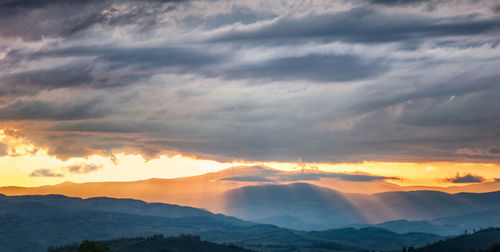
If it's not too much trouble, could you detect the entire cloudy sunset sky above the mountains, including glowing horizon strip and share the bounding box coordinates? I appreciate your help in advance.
[0,0,500,186]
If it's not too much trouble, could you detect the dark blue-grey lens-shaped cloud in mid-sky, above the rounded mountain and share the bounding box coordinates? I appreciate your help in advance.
[224,55,386,82]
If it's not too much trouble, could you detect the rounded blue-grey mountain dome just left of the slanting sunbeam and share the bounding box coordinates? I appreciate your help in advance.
[223,183,368,230]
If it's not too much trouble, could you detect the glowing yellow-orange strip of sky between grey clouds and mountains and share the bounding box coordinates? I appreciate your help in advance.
[0,130,500,187]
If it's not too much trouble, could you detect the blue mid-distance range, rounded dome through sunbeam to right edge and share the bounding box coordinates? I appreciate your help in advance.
[223,183,500,235]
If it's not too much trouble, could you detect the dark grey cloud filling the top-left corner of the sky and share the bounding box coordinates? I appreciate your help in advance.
[0,0,183,41]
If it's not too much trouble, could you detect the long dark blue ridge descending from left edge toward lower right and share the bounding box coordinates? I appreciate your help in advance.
[0,195,442,252]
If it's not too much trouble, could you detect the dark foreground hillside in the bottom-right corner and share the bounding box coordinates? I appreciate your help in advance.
[415,228,500,252]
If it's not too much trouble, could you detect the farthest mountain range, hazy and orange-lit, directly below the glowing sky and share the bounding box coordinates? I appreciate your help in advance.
[0,166,500,213]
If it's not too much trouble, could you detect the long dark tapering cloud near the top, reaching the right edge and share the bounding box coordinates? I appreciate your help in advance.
[213,8,500,43]
